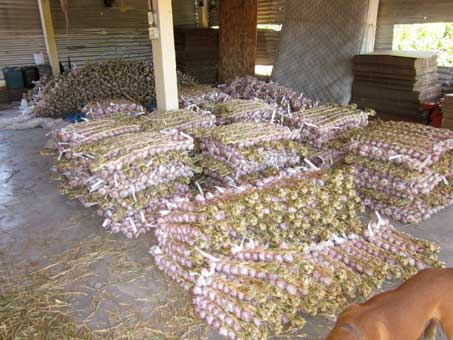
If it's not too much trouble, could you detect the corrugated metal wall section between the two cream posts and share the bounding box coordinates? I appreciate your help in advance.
[51,0,151,66]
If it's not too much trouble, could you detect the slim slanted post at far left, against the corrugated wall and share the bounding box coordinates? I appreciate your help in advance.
[38,0,60,76]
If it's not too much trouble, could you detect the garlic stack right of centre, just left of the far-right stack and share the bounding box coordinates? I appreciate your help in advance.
[284,104,374,168]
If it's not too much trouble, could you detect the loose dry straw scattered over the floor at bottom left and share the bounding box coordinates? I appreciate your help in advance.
[0,236,207,340]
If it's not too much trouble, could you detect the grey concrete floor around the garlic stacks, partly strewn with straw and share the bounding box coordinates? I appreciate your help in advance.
[0,105,453,340]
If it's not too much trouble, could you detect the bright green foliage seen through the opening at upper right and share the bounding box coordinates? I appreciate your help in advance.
[393,23,453,67]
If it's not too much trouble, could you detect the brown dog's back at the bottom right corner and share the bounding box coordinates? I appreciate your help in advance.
[326,269,453,340]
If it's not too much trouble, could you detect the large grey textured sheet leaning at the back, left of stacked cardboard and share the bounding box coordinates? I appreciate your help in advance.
[272,0,369,104]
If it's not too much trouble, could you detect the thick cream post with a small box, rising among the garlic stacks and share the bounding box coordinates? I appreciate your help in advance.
[151,0,179,112]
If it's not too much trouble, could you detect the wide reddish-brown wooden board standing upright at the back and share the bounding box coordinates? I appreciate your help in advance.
[219,0,258,82]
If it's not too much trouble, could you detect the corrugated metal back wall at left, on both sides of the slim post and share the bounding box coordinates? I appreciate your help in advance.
[0,0,197,79]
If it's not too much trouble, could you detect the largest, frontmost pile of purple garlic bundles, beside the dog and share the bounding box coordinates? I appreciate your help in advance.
[150,170,442,340]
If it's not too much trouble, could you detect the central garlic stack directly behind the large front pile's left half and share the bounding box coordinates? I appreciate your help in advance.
[195,123,306,186]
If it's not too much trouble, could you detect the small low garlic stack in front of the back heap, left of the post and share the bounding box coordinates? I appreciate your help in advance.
[82,99,146,120]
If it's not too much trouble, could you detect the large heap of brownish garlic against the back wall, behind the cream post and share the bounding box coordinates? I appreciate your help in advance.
[26,59,195,117]
